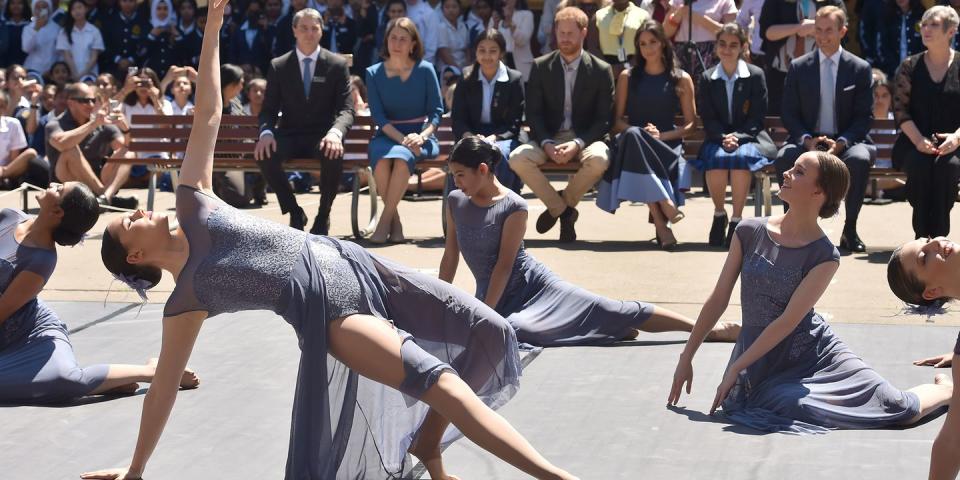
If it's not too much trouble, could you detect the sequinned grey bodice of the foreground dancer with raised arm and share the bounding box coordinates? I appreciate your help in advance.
[164,185,365,321]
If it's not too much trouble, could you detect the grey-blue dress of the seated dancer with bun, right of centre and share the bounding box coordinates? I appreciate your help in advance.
[723,218,920,434]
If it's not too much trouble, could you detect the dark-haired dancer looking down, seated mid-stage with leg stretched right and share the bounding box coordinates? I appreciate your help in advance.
[440,136,740,347]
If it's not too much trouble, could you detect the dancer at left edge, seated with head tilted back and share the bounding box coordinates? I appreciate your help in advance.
[0,182,199,404]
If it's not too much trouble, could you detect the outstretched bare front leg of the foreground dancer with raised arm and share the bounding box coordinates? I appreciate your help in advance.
[328,315,575,479]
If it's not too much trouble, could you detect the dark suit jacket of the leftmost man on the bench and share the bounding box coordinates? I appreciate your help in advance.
[259,47,354,138]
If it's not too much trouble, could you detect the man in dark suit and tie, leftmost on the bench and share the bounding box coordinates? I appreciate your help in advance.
[254,8,354,235]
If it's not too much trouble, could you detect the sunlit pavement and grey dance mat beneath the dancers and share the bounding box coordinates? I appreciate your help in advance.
[0,182,960,480]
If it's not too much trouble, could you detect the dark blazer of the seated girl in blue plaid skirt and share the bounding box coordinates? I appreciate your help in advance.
[697,63,777,158]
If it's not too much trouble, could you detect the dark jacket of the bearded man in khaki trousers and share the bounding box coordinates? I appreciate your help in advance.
[526,50,613,145]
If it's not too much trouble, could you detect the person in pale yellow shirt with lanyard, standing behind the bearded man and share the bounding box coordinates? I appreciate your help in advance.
[596,0,650,75]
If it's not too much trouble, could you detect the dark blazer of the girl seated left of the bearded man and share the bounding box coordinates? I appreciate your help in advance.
[450,67,524,140]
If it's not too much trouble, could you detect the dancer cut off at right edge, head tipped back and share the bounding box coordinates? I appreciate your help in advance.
[887,237,960,480]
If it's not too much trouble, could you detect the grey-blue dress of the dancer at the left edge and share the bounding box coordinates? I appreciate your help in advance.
[0,209,109,404]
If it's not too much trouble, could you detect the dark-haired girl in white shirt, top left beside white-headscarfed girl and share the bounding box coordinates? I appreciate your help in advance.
[57,0,105,81]
